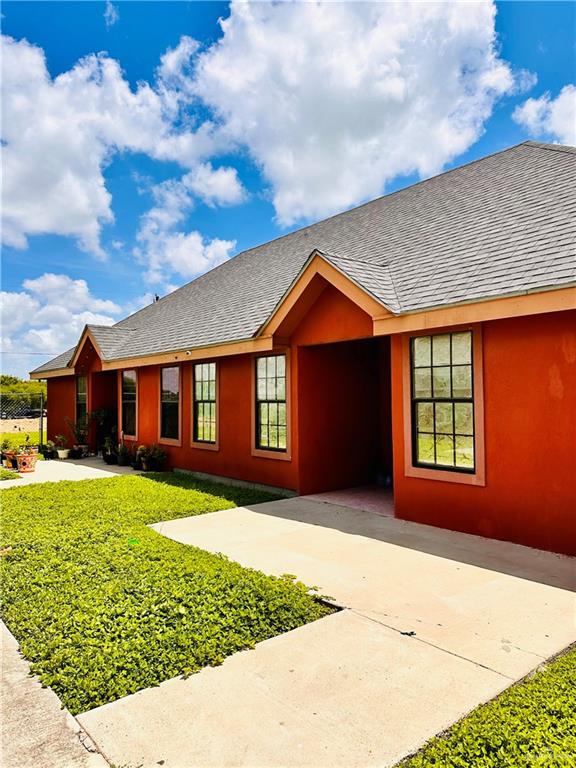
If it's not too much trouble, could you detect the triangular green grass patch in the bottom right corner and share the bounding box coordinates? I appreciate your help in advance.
[400,647,576,768]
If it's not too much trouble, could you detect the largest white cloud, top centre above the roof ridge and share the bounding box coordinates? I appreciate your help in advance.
[188,1,526,224]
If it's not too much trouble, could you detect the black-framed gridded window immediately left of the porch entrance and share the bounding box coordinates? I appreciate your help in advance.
[256,355,287,451]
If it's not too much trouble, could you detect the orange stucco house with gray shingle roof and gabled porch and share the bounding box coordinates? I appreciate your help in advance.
[31,142,576,554]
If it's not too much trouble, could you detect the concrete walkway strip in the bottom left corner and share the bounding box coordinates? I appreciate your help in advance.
[0,622,108,768]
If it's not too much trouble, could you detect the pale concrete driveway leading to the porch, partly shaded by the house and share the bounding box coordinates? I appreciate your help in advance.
[79,498,576,768]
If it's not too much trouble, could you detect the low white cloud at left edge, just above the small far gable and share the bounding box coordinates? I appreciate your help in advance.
[0,273,122,376]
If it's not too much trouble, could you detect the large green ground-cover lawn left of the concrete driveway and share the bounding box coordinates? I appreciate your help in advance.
[0,473,329,714]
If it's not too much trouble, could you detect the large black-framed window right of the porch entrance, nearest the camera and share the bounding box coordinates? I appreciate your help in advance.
[410,331,476,472]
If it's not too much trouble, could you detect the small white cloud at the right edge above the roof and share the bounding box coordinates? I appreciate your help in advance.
[512,85,576,145]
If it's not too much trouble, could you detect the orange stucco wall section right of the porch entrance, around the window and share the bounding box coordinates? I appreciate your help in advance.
[392,311,576,554]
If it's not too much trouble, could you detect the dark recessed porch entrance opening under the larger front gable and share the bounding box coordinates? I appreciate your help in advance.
[298,337,393,513]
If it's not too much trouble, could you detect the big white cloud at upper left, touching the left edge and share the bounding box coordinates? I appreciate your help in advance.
[2,36,222,258]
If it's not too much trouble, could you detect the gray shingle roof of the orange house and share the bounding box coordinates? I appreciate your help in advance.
[31,142,576,372]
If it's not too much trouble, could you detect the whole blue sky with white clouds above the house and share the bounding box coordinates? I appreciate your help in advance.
[2,2,576,375]
